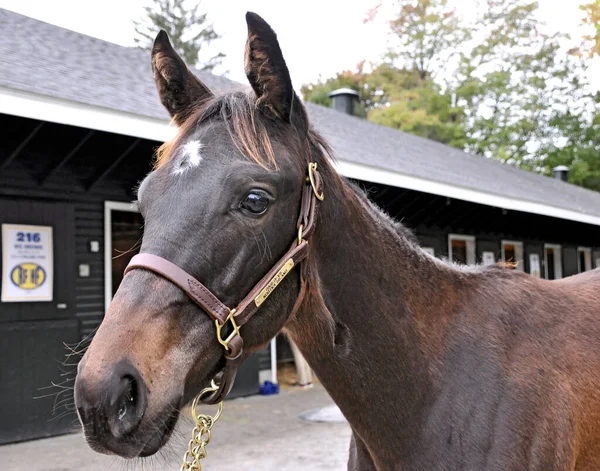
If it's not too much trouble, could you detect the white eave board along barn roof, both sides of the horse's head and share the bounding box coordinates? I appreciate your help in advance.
[0,87,600,226]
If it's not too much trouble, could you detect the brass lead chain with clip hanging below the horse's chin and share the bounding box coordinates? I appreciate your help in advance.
[181,381,223,471]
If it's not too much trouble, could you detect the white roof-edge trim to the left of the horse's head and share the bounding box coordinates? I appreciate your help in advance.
[0,87,176,141]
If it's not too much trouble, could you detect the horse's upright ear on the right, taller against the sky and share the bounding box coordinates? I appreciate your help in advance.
[245,12,307,131]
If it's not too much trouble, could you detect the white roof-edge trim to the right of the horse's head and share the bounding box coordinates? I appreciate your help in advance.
[334,159,600,226]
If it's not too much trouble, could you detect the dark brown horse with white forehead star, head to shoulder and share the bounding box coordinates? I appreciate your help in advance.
[75,13,600,471]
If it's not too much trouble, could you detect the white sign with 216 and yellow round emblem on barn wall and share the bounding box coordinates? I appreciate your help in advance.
[1,224,54,303]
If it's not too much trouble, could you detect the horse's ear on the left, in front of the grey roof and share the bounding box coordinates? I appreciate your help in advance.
[152,30,213,125]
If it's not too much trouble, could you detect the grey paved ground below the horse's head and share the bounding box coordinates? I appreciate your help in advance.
[0,385,350,471]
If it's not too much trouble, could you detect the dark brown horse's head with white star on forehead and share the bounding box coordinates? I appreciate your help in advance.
[75,13,324,457]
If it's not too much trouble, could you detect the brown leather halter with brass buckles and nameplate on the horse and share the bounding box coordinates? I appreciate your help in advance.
[124,163,324,404]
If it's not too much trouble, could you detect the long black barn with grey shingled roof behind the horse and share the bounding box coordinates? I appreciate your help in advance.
[0,9,600,443]
